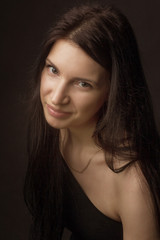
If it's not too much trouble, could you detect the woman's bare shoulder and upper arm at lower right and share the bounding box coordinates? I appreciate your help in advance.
[116,164,160,240]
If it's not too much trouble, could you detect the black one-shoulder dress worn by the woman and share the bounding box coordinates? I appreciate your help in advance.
[63,161,123,240]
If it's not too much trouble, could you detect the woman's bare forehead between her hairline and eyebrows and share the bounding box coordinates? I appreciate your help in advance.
[47,39,107,78]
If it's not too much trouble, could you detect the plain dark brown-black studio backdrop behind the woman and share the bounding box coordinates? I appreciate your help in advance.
[0,0,160,240]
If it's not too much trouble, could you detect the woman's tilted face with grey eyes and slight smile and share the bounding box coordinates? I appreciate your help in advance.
[40,40,109,129]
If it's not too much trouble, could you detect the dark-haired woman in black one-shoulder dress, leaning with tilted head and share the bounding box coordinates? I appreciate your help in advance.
[25,2,160,240]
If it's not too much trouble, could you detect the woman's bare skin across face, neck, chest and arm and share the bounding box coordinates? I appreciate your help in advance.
[40,39,160,240]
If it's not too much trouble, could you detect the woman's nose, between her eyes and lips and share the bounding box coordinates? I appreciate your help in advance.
[51,80,70,105]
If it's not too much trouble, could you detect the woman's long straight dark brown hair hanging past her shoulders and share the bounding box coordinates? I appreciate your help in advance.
[24,3,160,240]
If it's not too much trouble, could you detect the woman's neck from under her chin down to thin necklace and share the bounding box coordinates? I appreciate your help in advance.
[60,125,101,173]
